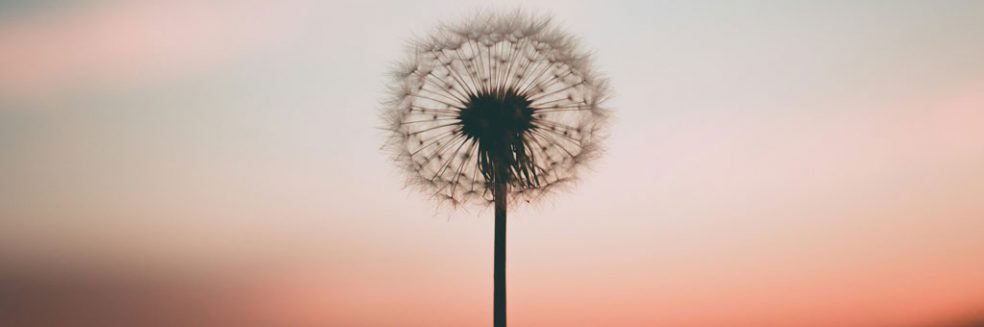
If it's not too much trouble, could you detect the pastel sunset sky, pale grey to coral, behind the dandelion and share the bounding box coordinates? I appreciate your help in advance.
[0,0,984,327]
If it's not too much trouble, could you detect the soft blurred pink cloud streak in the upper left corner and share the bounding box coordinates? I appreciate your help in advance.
[0,1,304,101]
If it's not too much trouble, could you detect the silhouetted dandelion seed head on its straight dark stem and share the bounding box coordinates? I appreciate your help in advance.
[384,12,607,326]
